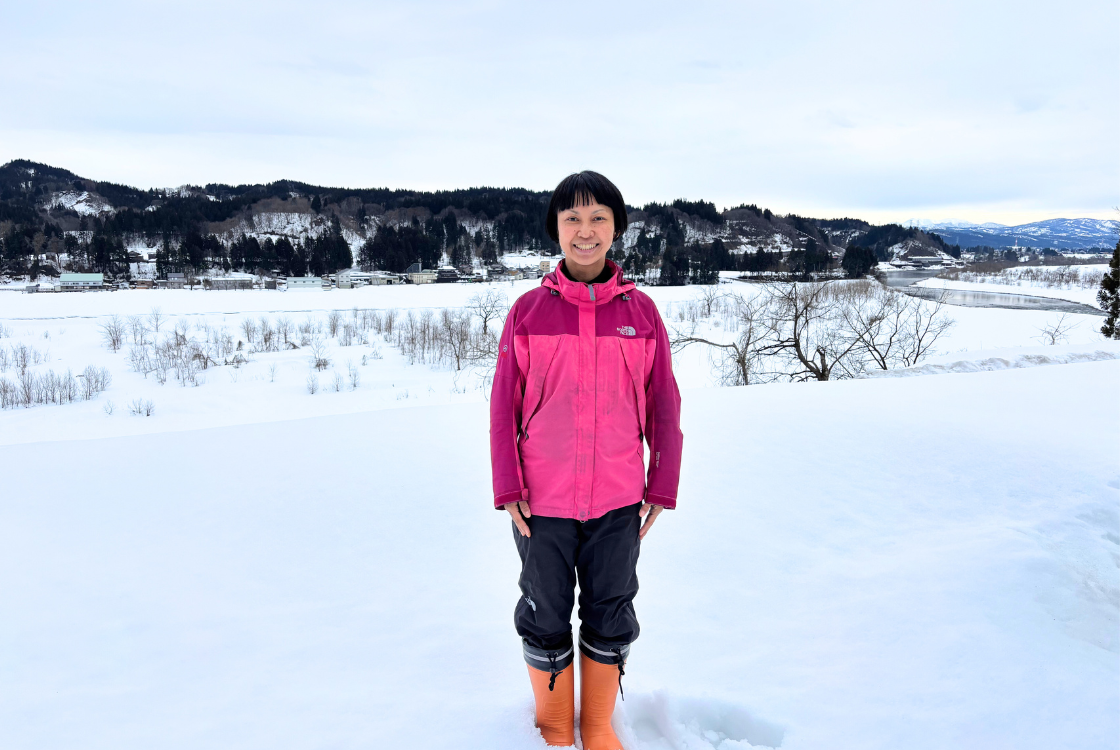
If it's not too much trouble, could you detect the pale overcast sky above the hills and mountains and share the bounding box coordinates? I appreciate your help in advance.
[0,0,1120,224]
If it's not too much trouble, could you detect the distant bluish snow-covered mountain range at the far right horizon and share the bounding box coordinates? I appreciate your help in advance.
[903,218,1120,250]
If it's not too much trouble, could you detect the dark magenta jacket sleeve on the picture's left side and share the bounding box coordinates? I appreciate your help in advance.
[491,302,525,508]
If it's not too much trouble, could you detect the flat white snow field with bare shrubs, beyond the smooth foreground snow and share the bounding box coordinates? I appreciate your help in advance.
[0,280,1120,446]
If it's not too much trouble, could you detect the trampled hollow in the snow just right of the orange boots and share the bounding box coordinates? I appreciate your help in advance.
[614,691,785,750]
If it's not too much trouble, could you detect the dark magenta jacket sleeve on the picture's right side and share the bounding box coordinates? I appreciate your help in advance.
[645,311,684,509]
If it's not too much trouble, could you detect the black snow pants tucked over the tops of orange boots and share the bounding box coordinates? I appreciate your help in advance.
[513,503,642,678]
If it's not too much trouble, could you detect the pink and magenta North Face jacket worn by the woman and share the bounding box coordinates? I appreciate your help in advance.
[491,261,683,521]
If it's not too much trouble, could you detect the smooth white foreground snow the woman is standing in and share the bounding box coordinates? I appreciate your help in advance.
[0,360,1120,750]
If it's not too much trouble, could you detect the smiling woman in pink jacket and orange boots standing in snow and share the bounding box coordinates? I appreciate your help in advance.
[491,171,682,750]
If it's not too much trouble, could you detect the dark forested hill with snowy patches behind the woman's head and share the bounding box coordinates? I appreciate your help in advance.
[0,160,959,283]
